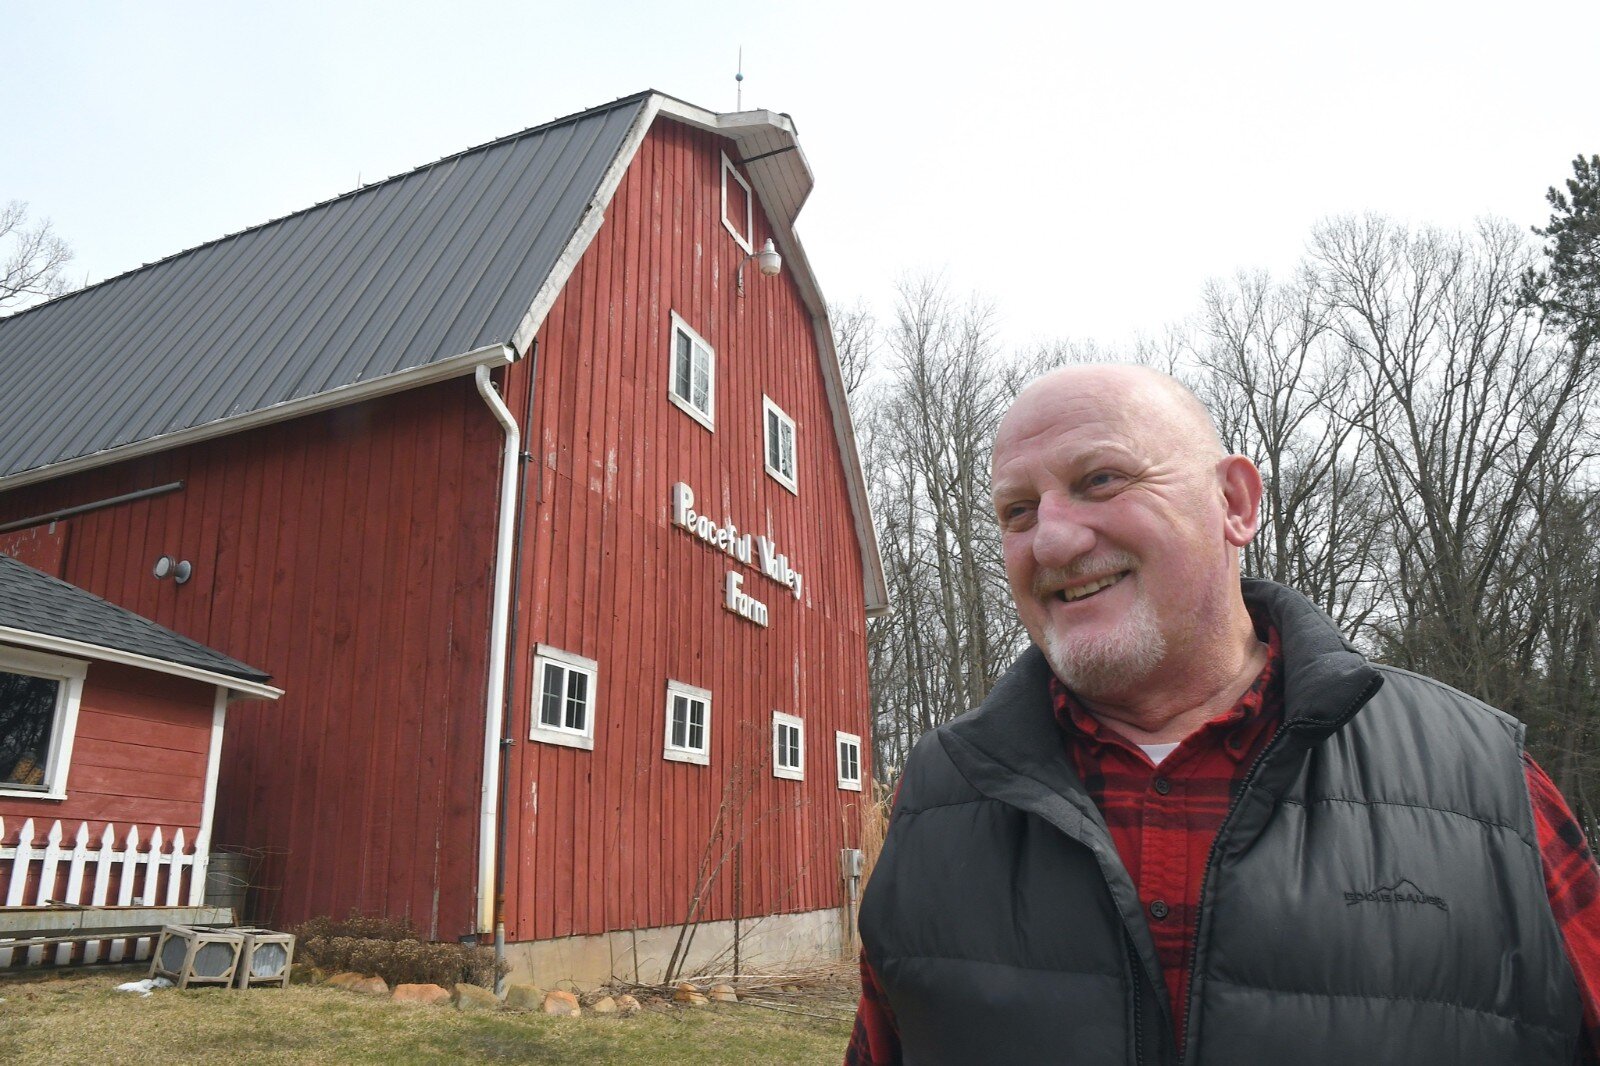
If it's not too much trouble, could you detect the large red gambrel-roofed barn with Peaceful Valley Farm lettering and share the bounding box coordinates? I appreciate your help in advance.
[0,93,886,980]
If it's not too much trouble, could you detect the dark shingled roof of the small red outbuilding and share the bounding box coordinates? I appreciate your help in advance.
[0,555,270,695]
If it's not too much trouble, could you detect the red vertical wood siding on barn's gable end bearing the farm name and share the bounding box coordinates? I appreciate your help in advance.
[506,120,870,940]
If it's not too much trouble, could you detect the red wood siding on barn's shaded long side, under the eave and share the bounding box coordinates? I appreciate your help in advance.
[0,378,501,938]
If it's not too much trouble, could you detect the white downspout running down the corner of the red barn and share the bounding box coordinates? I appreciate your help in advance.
[474,365,522,933]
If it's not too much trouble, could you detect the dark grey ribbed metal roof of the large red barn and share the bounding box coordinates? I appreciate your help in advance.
[0,93,650,479]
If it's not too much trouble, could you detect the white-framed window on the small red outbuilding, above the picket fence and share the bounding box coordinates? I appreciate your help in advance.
[0,648,90,800]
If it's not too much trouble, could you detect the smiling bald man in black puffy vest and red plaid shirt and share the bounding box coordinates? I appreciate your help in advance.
[846,367,1600,1066]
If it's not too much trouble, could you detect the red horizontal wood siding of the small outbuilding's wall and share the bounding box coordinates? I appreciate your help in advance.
[0,663,216,847]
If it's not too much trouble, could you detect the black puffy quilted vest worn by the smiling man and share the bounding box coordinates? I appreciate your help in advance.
[861,581,1581,1066]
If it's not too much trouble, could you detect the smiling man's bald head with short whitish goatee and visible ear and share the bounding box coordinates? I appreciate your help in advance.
[994,367,1259,701]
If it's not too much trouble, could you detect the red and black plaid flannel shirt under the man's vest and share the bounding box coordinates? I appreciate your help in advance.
[845,627,1600,1066]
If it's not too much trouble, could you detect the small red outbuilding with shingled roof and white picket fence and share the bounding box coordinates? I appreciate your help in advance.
[0,555,282,928]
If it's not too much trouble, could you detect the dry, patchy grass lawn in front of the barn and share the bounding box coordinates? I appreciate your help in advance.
[0,967,850,1066]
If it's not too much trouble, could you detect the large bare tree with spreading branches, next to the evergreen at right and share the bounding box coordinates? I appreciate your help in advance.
[1312,218,1595,704]
